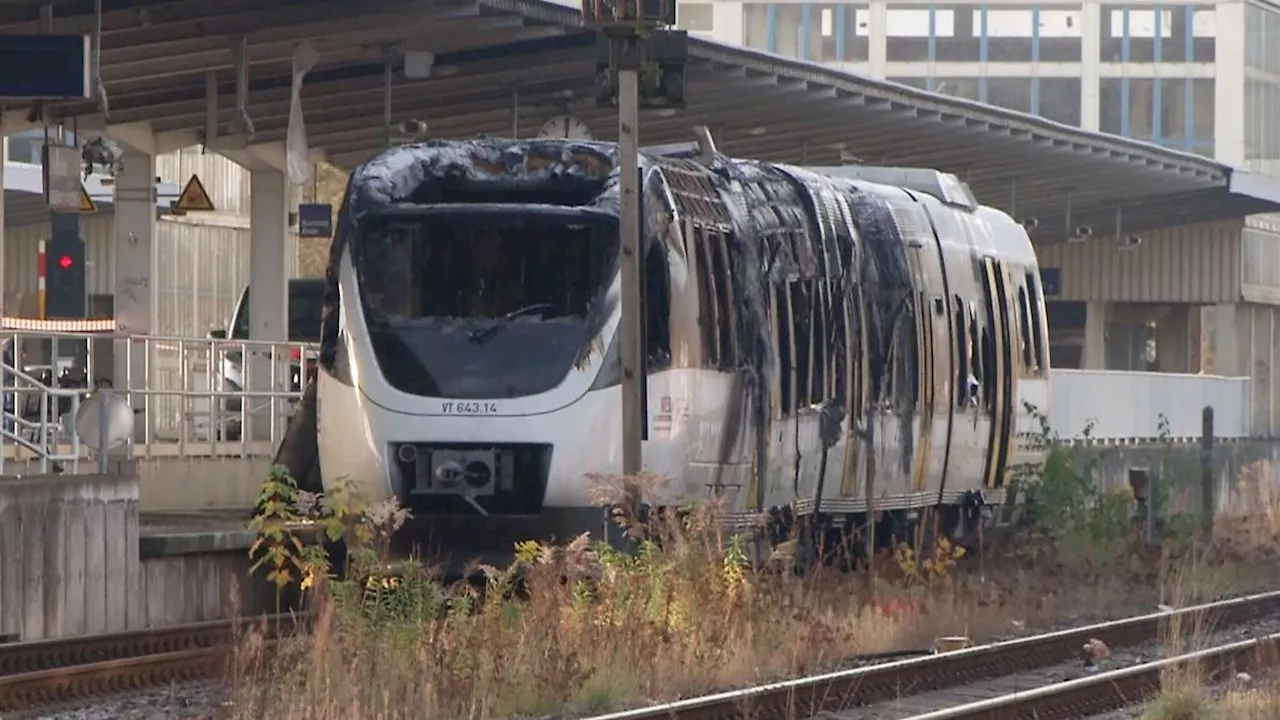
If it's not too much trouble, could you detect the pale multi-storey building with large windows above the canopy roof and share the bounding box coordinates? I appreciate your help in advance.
[680,1,1228,158]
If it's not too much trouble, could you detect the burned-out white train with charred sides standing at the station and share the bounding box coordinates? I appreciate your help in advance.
[290,138,1048,561]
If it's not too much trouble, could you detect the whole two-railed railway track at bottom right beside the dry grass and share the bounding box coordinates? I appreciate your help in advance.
[590,592,1280,720]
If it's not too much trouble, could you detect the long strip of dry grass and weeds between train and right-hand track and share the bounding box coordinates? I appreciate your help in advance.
[233,466,1280,720]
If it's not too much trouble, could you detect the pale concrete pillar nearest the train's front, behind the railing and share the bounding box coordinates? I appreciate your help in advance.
[246,169,285,441]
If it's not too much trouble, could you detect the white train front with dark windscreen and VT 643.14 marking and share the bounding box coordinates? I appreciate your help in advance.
[317,147,620,559]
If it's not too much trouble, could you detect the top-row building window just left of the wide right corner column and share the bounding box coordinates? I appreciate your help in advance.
[1098,5,1217,63]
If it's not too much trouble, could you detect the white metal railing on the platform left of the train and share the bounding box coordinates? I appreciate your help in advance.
[0,332,316,468]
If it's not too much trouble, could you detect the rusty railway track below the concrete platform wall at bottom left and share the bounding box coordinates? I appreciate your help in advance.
[0,614,308,717]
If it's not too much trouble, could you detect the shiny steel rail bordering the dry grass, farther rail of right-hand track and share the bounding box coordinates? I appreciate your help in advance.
[588,592,1280,720]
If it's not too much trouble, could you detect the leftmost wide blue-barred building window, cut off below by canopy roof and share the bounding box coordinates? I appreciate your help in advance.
[742,3,870,63]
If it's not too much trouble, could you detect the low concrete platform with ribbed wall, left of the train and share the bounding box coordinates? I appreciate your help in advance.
[0,474,297,642]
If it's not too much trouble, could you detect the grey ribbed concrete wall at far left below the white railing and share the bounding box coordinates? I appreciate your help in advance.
[0,475,145,641]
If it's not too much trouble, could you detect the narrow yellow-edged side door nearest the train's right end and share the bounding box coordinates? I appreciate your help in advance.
[982,258,1018,488]
